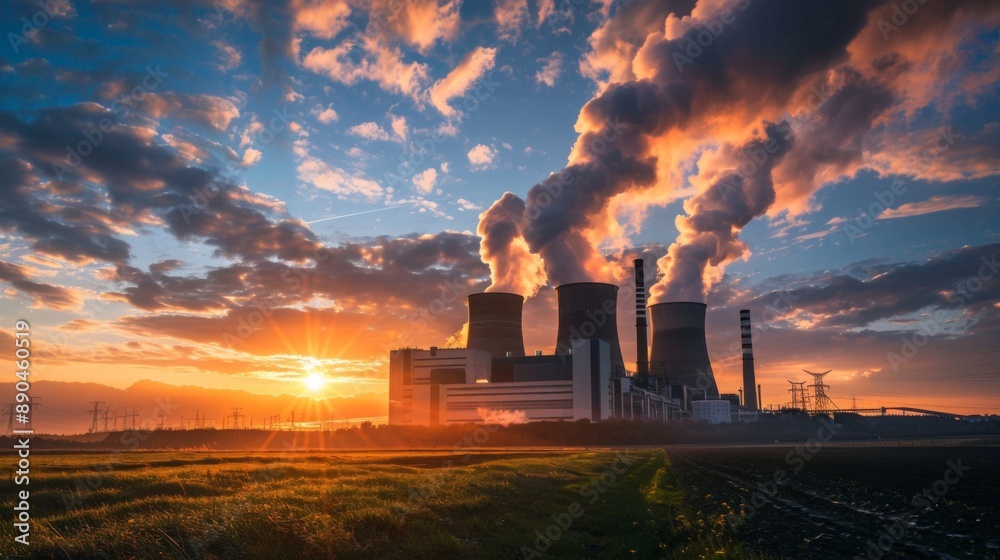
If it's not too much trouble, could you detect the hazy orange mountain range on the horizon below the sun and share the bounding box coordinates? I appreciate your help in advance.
[0,380,389,434]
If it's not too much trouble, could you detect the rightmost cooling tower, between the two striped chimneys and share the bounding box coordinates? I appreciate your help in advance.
[649,302,719,398]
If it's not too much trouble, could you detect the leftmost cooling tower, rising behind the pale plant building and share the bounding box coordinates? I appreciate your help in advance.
[465,292,524,358]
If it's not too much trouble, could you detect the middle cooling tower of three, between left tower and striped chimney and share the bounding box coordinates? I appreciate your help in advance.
[556,282,625,374]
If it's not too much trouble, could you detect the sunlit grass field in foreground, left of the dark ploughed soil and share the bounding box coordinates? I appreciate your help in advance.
[0,450,772,560]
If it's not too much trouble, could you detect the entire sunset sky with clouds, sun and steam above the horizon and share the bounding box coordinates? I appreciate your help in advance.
[0,0,1000,428]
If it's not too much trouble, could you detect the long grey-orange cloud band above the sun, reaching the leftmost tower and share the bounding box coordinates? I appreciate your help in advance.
[104,229,486,320]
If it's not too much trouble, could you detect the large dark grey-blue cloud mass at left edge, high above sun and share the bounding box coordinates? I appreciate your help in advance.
[0,103,316,270]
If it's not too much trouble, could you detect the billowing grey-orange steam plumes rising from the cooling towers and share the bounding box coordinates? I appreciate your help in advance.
[479,0,1000,302]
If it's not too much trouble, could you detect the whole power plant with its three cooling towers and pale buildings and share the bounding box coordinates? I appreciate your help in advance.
[389,259,756,426]
